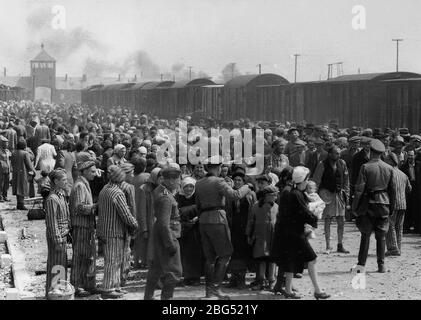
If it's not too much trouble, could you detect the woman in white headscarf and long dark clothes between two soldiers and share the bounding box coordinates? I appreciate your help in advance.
[175,177,204,286]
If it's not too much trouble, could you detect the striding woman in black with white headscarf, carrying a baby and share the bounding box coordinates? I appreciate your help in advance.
[274,166,330,299]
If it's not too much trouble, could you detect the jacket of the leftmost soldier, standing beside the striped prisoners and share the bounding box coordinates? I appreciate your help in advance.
[153,185,181,248]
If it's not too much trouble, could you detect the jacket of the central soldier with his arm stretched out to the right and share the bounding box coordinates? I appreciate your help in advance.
[195,175,249,224]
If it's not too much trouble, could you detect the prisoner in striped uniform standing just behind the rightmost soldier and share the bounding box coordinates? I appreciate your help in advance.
[385,153,412,256]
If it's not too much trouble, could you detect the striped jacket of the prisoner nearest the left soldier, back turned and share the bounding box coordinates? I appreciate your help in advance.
[97,183,138,239]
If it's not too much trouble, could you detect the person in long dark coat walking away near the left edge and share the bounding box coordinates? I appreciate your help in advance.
[11,140,35,210]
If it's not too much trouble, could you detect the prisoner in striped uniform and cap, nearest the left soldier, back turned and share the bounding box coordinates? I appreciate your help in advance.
[97,165,138,298]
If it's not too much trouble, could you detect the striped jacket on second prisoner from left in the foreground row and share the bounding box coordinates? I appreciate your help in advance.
[69,176,95,228]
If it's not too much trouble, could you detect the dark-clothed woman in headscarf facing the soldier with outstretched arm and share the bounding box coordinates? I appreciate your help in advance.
[226,171,256,289]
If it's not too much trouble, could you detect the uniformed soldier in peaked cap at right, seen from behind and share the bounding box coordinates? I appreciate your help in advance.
[352,139,396,273]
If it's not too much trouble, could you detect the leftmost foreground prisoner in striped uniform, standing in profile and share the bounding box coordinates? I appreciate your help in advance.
[45,169,70,299]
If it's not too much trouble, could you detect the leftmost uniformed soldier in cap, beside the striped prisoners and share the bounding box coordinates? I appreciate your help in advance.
[144,167,182,300]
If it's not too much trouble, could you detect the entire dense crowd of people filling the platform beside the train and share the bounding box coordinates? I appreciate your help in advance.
[0,101,421,299]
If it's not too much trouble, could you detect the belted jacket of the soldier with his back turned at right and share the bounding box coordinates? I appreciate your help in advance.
[352,159,396,216]
